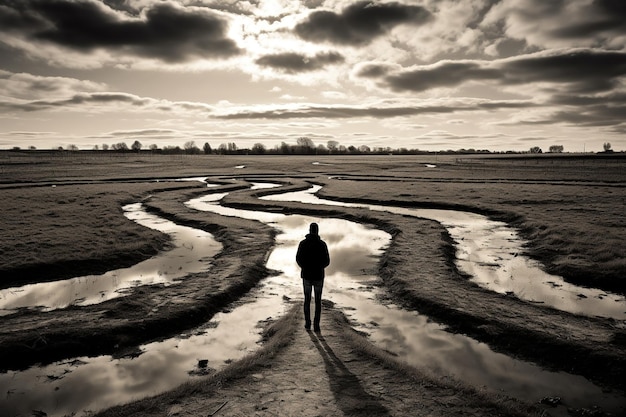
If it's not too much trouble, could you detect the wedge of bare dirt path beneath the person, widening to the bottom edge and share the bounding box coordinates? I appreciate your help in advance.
[157,308,536,417]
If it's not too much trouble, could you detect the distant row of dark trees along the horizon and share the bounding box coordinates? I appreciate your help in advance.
[7,136,613,155]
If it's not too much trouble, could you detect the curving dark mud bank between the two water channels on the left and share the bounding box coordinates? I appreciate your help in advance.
[0,188,273,370]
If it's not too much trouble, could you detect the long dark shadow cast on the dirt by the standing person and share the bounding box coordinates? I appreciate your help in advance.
[309,332,390,416]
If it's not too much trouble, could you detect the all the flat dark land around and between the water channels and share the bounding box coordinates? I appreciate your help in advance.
[0,152,626,415]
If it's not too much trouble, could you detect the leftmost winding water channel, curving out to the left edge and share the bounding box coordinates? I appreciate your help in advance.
[0,204,222,315]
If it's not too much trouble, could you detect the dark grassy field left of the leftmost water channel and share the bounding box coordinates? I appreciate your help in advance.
[0,182,200,288]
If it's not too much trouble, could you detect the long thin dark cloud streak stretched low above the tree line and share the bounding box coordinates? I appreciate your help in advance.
[216,101,535,120]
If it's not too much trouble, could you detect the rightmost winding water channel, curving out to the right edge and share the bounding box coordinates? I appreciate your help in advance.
[261,186,626,320]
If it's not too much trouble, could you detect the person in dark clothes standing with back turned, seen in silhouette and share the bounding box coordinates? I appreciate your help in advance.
[296,223,330,332]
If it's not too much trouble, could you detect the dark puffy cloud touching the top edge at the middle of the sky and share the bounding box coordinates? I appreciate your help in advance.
[295,1,432,46]
